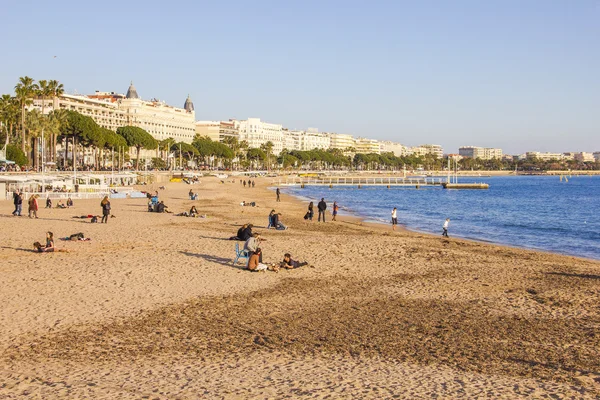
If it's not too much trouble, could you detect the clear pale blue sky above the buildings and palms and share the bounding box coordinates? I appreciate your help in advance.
[0,0,600,153]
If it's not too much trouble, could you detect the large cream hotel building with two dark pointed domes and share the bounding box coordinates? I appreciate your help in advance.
[119,82,196,143]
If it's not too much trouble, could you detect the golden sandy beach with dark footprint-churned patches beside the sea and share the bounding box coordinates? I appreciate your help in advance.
[0,177,600,399]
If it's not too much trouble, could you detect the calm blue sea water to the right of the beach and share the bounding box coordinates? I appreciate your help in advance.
[282,176,600,259]
